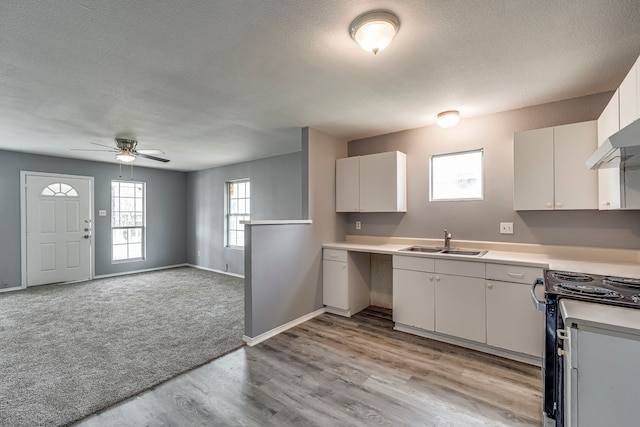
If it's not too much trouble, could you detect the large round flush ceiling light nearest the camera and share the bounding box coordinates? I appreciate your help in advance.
[349,10,400,54]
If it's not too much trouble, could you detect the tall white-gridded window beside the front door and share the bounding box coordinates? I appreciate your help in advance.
[111,181,146,261]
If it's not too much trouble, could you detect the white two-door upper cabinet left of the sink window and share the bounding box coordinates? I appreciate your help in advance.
[336,151,407,212]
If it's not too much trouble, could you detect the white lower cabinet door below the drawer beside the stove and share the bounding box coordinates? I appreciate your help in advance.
[486,281,545,357]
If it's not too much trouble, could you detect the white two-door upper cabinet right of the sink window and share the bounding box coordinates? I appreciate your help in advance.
[513,121,598,210]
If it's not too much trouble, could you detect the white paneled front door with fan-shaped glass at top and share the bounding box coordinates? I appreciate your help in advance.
[23,173,93,286]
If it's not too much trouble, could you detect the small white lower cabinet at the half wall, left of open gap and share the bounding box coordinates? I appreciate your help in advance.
[322,249,370,316]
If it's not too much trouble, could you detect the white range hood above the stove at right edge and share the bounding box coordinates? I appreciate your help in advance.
[587,120,640,169]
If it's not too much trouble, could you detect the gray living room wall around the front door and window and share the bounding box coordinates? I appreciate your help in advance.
[0,151,187,286]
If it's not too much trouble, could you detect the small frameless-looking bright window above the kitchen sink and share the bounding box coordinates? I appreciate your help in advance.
[429,148,484,202]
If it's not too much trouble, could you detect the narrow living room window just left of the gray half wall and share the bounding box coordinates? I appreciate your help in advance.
[227,179,251,248]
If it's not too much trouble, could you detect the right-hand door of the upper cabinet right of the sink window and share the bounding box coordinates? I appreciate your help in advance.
[553,120,598,209]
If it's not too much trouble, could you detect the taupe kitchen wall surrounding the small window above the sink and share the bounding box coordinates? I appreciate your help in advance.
[348,93,640,249]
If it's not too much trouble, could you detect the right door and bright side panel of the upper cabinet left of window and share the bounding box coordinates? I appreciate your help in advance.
[360,151,406,212]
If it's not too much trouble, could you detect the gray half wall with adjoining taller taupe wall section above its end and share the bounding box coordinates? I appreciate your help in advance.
[245,129,347,337]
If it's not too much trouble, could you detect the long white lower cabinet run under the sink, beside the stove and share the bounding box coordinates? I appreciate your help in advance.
[393,255,545,360]
